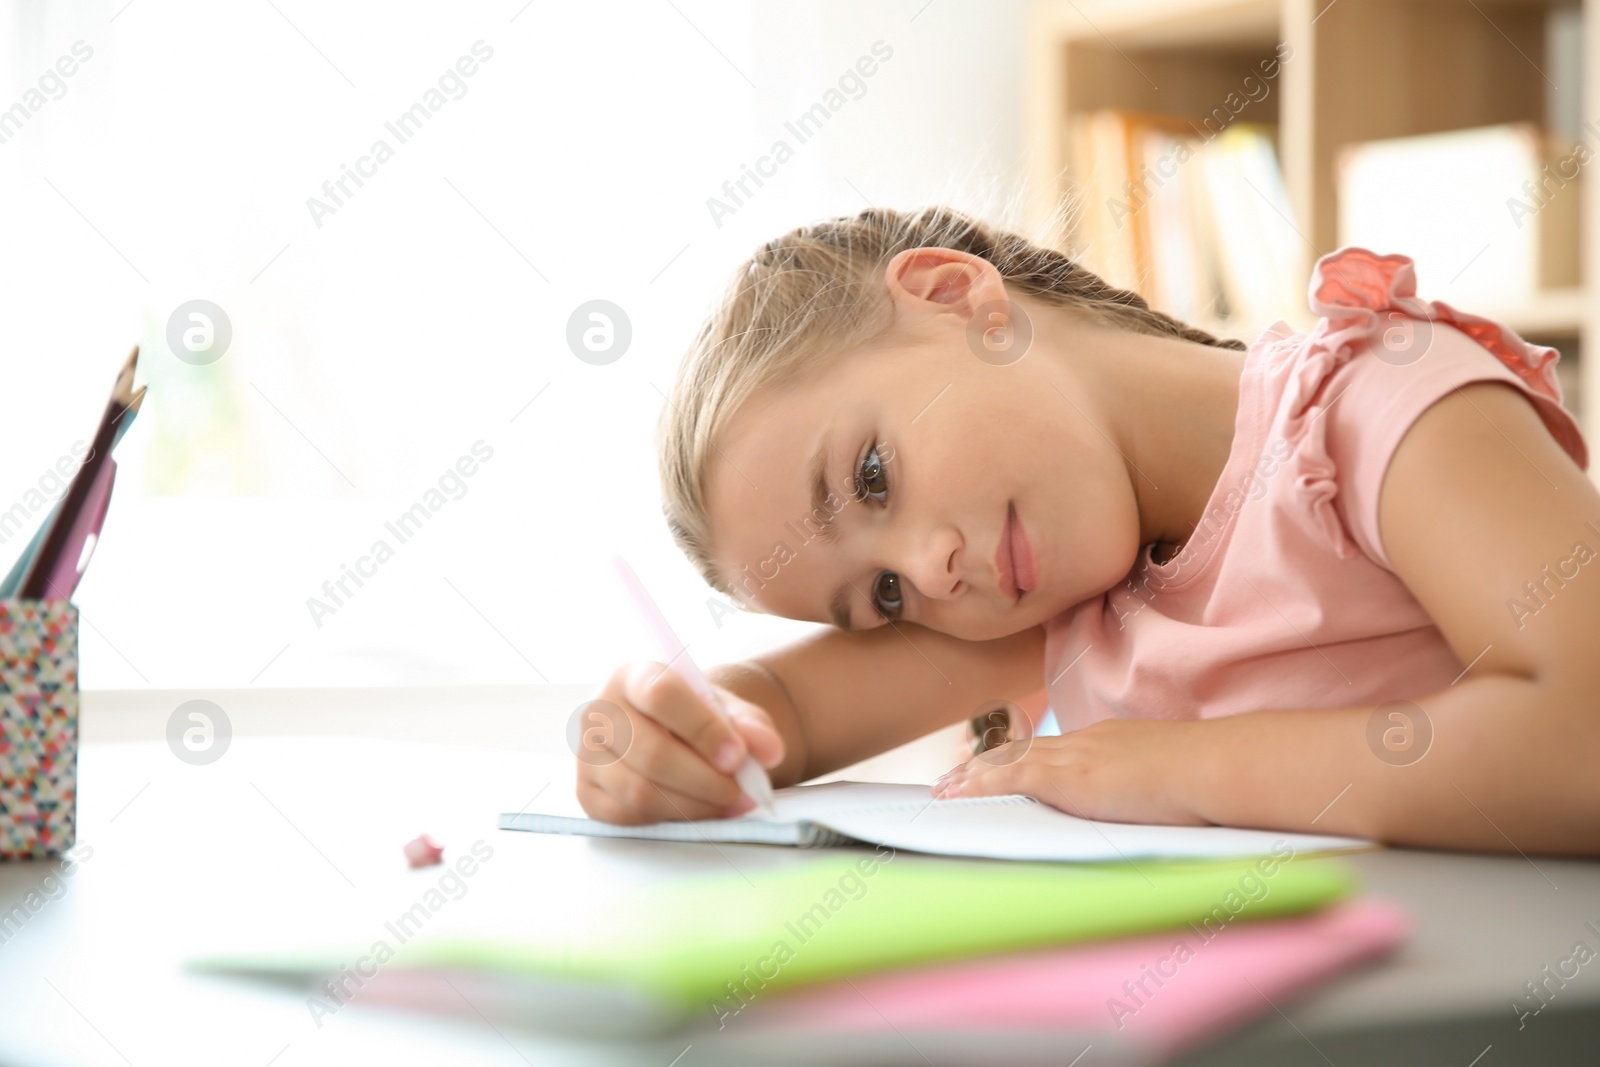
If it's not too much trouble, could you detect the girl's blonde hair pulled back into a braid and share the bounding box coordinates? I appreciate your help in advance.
[656,206,1245,603]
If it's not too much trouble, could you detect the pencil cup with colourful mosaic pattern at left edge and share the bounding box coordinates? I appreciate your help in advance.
[0,600,78,859]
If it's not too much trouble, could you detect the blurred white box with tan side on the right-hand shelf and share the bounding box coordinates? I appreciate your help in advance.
[1338,123,1592,310]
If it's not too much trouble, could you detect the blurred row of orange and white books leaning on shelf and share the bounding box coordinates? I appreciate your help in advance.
[1067,109,1310,339]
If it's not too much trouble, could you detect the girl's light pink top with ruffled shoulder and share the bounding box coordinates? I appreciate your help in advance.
[1045,248,1589,731]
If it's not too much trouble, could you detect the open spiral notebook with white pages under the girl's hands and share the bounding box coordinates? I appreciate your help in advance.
[499,782,1371,862]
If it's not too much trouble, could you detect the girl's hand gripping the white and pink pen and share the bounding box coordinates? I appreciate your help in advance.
[570,661,784,824]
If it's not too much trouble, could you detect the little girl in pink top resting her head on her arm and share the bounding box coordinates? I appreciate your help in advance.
[578,208,1600,853]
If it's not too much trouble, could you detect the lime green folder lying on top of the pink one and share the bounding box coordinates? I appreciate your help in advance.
[197,849,1354,1030]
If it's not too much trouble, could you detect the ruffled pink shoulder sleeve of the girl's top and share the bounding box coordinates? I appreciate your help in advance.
[1280,246,1589,566]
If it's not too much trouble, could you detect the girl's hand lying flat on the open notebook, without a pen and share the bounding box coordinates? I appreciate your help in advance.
[933,718,1208,825]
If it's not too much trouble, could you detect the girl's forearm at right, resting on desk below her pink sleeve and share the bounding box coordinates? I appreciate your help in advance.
[1174,675,1600,854]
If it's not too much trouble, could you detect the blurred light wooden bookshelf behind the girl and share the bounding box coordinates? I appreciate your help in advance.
[1024,0,1600,454]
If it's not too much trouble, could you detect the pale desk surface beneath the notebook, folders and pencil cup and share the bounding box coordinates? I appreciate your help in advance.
[0,686,1600,1067]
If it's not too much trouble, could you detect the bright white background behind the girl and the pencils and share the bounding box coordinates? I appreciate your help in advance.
[0,0,1022,688]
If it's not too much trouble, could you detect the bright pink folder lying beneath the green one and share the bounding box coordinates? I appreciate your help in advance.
[742,899,1408,1059]
